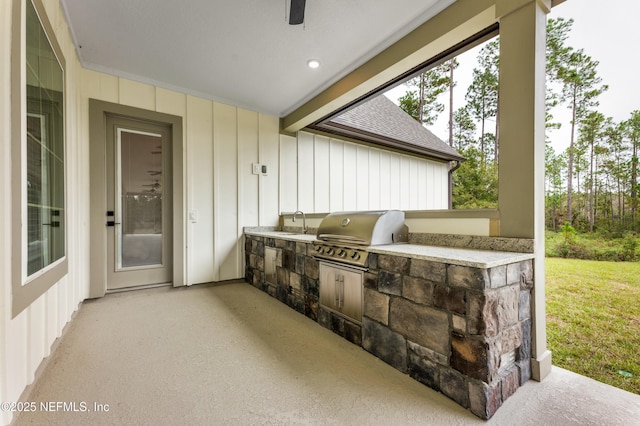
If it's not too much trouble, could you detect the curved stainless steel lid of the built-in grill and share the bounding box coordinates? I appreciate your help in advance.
[317,210,409,246]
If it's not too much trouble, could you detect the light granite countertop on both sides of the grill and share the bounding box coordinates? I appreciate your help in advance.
[245,227,535,269]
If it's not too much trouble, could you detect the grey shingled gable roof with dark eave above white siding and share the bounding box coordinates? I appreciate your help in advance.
[316,95,464,161]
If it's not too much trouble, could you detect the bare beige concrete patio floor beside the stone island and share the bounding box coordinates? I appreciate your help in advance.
[14,282,640,425]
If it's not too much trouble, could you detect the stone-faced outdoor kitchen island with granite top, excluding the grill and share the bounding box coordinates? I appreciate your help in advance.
[245,228,534,419]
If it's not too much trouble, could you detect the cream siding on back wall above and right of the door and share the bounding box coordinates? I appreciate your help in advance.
[83,74,279,284]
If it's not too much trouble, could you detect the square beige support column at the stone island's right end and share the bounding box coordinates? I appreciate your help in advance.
[496,0,551,380]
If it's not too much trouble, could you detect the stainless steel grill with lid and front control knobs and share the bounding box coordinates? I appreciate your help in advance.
[313,210,409,269]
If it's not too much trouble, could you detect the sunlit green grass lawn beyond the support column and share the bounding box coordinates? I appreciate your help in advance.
[545,258,640,395]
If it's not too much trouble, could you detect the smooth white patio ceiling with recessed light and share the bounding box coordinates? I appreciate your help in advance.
[61,0,455,117]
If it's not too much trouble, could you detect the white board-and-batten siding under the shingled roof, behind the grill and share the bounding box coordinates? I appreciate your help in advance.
[280,132,449,213]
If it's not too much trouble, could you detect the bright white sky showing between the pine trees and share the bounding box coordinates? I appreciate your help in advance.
[387,0,640,153]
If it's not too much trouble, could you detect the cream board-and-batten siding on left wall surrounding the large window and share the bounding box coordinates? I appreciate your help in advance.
[0,1,89,424]
